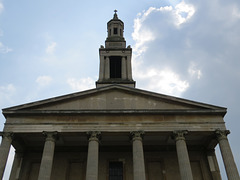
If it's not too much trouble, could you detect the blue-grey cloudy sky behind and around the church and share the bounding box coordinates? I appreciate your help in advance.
[0,0,240,179]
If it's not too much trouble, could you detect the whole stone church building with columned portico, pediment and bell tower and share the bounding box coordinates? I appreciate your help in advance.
[0,11,240,180]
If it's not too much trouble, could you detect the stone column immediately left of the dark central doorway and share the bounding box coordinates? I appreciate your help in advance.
[86,131,101,180]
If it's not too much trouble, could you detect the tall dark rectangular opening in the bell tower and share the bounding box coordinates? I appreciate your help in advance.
[110,56,122,78]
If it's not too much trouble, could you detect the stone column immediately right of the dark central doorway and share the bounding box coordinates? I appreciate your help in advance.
[130,131,146,180]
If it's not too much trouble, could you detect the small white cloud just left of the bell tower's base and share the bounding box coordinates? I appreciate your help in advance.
[67,77,95,91]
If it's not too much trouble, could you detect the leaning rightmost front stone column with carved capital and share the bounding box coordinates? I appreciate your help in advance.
[215,129,240,180]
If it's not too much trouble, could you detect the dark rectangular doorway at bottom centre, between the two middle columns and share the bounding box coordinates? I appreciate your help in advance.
[109,161,123,180]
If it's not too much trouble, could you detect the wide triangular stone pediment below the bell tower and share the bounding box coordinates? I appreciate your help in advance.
[3,85,226,113]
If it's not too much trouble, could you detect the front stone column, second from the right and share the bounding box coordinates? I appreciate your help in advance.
[173,130,193,180]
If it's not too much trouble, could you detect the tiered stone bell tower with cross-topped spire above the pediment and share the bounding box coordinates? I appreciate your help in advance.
[96,10,135,88]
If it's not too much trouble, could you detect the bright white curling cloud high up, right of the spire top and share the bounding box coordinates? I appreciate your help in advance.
[132,1,195,56]
